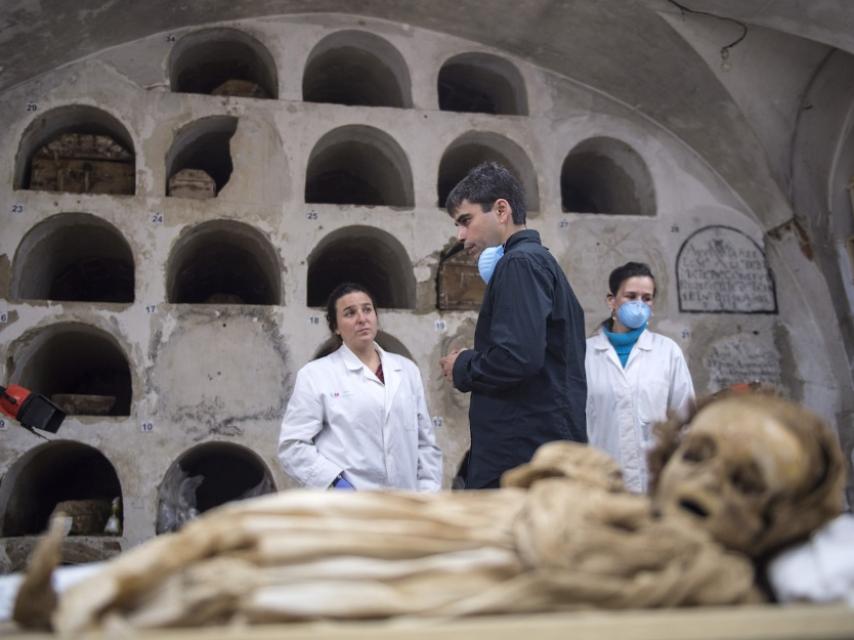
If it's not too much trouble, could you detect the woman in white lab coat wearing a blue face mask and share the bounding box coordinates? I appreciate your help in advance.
[584,262,694,493]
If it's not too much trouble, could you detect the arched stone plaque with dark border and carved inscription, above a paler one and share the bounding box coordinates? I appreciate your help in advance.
[676,225,777,313]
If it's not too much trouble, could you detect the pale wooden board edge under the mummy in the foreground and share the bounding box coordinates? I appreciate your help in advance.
[0,605,854,640]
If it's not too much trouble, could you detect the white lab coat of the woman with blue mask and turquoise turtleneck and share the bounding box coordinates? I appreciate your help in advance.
[584,329,694,493]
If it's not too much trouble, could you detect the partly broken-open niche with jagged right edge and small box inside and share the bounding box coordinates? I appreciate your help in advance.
[166,116,237,198]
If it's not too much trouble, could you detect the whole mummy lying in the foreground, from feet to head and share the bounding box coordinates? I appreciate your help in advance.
[15,396,844,633]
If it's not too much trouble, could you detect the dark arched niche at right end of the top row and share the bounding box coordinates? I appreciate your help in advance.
[438,53,528,116]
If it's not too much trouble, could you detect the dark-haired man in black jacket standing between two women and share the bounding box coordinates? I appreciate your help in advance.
[441,162,587,489]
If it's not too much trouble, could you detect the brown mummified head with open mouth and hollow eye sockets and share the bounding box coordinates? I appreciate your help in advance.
[653,395,842,556]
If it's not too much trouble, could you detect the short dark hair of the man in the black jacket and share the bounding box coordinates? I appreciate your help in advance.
[445,162,527,224]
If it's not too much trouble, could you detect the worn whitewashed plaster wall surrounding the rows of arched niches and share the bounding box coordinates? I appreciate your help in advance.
[0,10,850,546]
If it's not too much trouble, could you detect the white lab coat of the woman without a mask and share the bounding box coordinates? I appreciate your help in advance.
[278,343,442,491]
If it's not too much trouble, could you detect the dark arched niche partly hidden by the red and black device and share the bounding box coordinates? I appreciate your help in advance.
[7,322,133,416]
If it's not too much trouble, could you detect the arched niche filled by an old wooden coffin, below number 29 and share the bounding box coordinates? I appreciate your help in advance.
[14,105,136,195]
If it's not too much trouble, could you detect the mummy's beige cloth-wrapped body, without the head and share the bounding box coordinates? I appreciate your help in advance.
[20,443,758,634]
